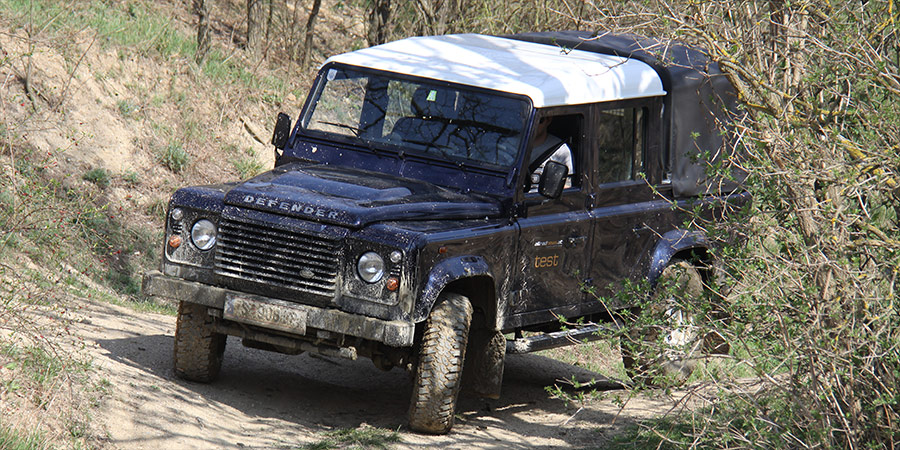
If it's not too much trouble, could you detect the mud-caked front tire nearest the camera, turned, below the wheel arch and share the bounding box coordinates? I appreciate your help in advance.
[409,293,472,434]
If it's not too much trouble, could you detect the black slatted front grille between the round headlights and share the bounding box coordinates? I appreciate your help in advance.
[216,217,340,298]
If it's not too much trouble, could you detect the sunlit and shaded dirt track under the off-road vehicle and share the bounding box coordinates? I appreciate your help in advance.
[74,303,672,449]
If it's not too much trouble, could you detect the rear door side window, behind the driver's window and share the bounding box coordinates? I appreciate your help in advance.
[594,108,647,184]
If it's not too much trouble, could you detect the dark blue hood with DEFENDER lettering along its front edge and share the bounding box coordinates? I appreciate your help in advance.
[225,163,501,228]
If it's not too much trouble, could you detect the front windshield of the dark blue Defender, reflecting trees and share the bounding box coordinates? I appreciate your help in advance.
[302,66,529,167]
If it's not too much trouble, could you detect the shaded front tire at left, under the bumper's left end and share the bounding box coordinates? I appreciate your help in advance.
[174,302,226,383]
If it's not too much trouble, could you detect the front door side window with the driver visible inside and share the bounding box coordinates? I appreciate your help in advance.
[526,114,584,193]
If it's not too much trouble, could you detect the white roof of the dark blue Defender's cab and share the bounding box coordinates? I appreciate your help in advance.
[325,34,666,108]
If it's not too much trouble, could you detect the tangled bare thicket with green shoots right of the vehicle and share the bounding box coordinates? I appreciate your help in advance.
[592,0,900,448]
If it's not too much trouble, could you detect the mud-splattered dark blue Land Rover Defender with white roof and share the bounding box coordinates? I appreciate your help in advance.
[144,32,748,433]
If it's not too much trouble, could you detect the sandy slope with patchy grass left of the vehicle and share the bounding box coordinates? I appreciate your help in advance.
[0,0,358,449]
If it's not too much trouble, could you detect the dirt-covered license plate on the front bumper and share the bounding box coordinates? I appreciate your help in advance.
[223,295,306,334]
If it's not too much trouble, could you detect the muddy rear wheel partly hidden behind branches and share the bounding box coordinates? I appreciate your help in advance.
[621,261,704,387]
